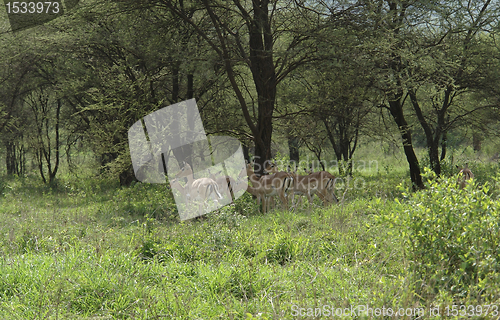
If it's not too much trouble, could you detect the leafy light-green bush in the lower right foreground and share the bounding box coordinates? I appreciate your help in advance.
[402,172,500,301]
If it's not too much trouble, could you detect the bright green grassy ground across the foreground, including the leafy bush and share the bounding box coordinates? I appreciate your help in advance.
[0,144,500,319]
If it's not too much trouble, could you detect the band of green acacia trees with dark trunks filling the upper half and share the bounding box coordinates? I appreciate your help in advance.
[0,0,500,188]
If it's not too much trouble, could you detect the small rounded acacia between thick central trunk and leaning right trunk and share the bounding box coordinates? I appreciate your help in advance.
[281,63,373,175]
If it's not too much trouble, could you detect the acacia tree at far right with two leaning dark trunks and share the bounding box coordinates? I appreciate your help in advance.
[354,0,499,188]
